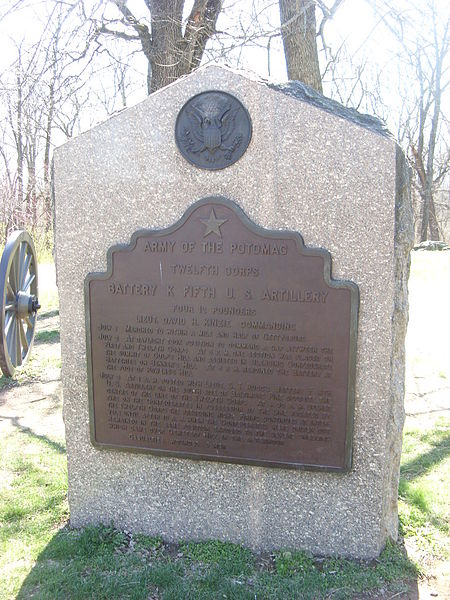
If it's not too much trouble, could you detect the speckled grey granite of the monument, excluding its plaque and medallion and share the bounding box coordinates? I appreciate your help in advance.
[54,67,412,557]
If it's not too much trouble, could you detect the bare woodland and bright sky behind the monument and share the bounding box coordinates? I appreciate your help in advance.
[0,0,450,251]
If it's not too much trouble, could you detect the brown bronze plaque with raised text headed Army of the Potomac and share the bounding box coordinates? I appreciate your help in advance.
[85,197,358,470]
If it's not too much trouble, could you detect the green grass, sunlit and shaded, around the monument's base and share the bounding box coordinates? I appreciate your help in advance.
[0,254,450,600]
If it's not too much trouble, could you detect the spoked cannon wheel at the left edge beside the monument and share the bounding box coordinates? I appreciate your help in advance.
[0,231,40,377]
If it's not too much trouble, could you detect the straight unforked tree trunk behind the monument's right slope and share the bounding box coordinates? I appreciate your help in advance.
[279,0,322,93]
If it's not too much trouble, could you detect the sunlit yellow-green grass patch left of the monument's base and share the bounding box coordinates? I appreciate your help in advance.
[0,431,68,599]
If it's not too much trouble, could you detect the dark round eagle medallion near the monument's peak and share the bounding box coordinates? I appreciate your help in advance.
[175,90,252,170]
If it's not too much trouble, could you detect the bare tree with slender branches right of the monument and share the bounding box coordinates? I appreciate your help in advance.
[371,0,450,241]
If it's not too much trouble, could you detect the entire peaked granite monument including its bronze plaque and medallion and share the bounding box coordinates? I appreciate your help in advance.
[54,66,412,558]
